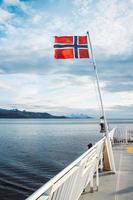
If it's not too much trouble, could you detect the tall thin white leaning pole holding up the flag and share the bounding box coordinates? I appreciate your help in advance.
[87,32,116,173]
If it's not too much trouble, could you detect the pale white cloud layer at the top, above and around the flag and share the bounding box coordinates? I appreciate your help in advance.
[2,0,133,62]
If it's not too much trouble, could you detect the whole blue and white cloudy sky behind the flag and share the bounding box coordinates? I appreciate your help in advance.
[0,0,133,118]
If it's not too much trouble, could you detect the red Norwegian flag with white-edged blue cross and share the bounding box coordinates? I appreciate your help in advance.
[54,36,89,59]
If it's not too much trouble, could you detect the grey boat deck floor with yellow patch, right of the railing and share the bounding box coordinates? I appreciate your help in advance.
[80,144,133,200]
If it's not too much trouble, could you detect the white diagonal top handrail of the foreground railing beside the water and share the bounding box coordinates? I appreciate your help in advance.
[26,137,105,200]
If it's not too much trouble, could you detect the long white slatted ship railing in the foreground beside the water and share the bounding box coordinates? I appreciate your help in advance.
[26,137,105,200]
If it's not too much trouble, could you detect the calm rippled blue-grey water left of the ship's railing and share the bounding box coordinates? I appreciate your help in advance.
[0,119,132,200]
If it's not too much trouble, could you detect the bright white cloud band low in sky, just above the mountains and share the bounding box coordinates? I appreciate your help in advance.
[0,74,133,116]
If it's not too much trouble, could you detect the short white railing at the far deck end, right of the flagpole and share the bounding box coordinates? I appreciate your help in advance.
[113,125,133,144]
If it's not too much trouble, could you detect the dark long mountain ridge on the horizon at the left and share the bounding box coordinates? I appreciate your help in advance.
[0,108,66,119]
